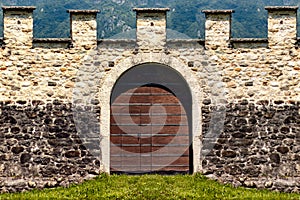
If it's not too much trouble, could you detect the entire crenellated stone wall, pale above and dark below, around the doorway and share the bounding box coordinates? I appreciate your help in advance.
[0,6,300,192]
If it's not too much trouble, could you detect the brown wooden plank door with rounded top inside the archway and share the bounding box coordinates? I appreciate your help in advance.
[110,84,190,173]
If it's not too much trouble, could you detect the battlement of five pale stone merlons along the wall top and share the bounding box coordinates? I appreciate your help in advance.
[0,6,299,49]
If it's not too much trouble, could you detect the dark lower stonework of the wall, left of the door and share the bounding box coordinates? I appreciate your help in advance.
[0,100,100,192]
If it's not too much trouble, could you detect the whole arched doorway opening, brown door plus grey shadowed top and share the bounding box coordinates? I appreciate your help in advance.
[110,63,193,173]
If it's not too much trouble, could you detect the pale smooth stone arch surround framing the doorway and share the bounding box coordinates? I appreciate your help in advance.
[99,53,202,173]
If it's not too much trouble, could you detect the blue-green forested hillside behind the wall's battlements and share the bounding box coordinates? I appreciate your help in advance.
[0,0,300,38]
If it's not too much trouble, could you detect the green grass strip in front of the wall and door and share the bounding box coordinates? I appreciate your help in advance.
[0,174,300,200]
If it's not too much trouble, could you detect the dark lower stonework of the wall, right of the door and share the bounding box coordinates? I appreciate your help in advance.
[202,99,300,192]
